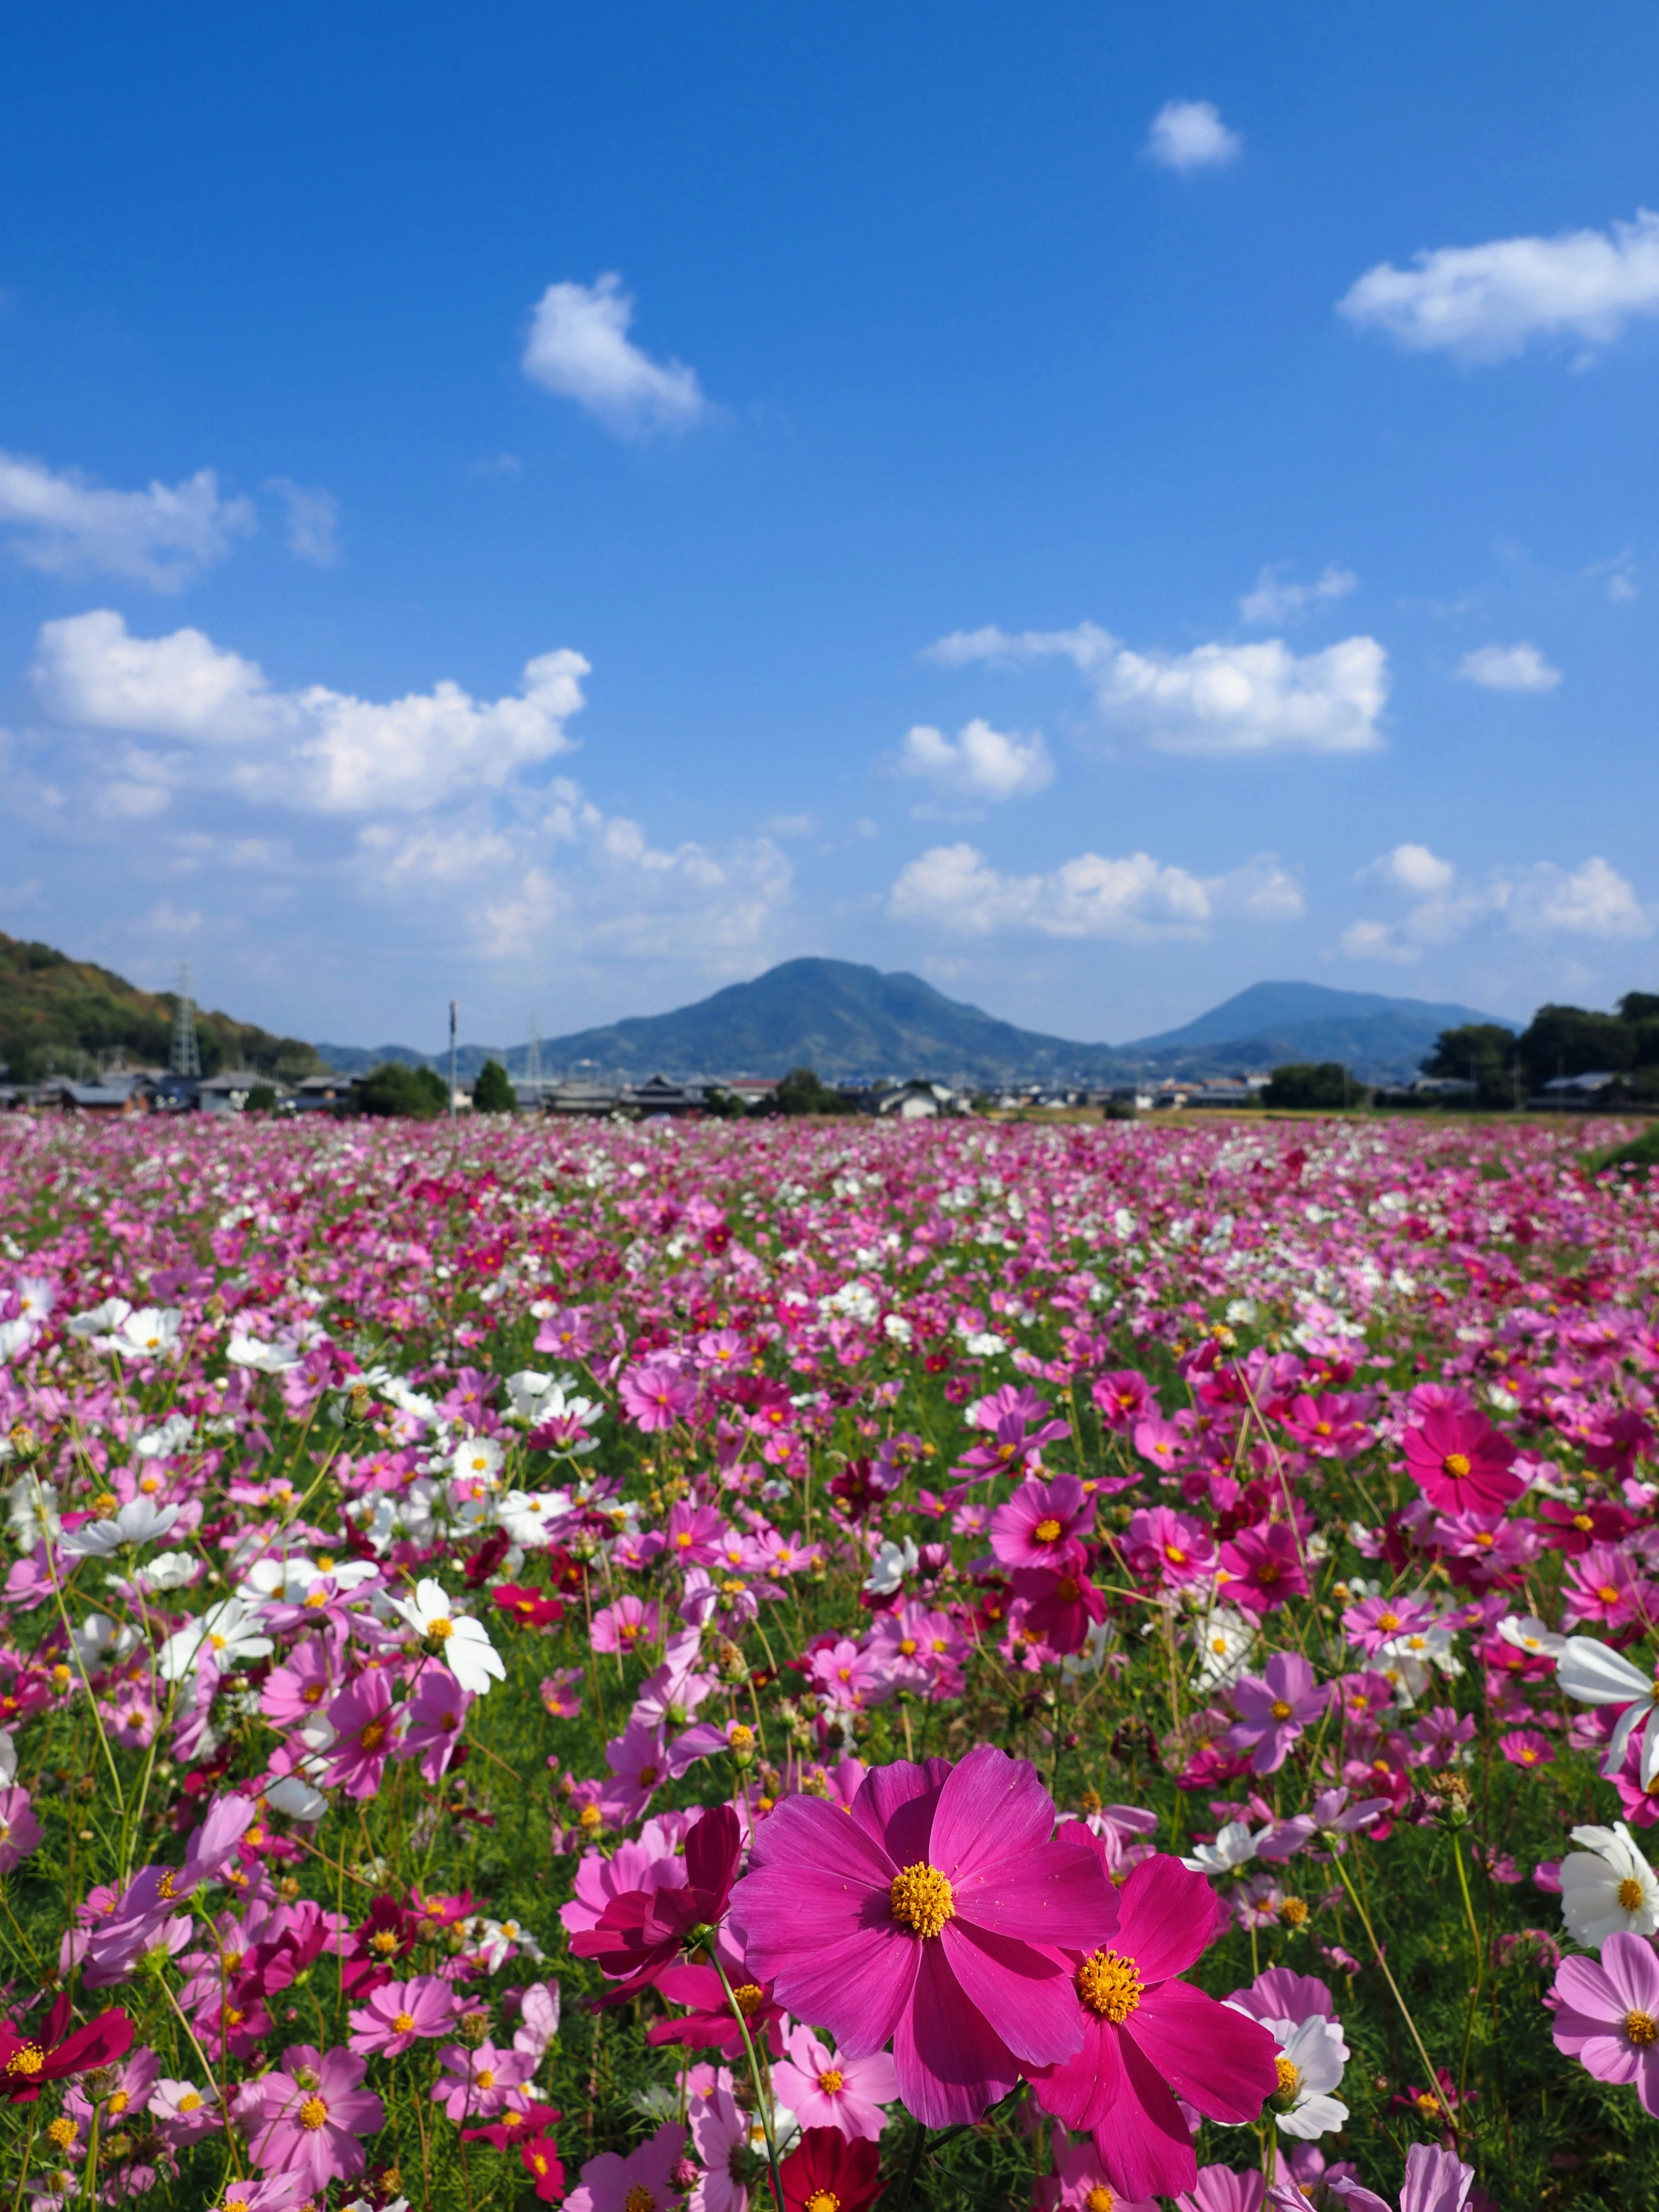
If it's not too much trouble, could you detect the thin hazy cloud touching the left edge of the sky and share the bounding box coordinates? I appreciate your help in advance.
[0,454,259,591]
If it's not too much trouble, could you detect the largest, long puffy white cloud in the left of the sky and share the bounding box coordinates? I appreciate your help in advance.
[31,608,588,814]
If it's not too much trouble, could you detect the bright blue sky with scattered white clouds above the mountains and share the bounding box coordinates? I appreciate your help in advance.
[0,0,1659,1044]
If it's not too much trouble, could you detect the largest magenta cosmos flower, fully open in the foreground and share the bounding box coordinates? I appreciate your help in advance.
[732,1743,1119,2128]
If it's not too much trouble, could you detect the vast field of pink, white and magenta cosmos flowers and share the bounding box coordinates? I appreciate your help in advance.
[0,1117,1659,2212]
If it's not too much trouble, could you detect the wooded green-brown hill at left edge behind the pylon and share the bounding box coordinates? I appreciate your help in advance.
[0,934,321,1082]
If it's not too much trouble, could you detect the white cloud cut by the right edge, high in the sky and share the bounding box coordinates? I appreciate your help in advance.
[1338,208,1659,363]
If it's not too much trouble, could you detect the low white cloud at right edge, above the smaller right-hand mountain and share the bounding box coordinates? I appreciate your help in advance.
[1341,845,1653,962]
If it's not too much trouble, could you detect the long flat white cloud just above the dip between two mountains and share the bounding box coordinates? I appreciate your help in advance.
[887,845,1303,942]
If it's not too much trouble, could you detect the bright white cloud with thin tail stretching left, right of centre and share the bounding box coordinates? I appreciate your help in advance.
[929,622,1389,756]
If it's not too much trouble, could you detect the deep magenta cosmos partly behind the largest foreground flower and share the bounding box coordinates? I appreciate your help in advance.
[1031,1856,1278,2196]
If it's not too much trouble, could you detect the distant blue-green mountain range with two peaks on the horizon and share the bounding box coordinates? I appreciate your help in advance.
[316,960,1515,1086]
